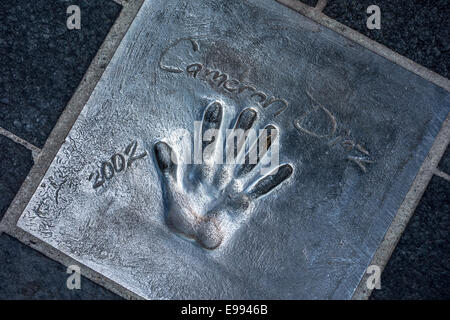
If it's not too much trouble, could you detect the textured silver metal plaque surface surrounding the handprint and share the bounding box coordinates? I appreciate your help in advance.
[18,0,450,299]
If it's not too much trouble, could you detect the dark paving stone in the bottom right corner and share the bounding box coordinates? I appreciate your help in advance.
[371,176,450,300]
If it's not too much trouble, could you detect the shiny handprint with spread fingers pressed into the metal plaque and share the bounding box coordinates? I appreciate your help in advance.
[154,102,293,250]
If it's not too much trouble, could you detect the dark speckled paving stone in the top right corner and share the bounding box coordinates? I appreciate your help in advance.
[324,0,450,78]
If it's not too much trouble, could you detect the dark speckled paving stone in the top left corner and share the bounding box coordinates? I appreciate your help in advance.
[0,0,121,147]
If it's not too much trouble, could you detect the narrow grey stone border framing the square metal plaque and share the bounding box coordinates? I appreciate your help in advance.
[0,0,450,299]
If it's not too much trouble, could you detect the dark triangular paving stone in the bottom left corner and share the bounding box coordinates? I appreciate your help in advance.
[0,234,121,300]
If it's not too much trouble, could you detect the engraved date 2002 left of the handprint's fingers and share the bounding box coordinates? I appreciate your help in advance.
[89,141,147,189]
